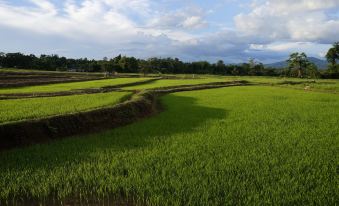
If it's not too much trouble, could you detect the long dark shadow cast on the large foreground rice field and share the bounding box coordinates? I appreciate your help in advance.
[0,94,227,160]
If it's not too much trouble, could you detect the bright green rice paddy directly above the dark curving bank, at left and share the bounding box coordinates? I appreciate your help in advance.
[0,92,131,124]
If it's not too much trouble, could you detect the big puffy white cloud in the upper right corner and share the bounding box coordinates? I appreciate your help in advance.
[235,0,339,43]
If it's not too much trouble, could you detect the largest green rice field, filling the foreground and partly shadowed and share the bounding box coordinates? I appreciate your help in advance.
[0,86,339,205]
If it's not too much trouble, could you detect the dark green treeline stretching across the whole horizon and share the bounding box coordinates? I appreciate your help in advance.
[0,43,339,78]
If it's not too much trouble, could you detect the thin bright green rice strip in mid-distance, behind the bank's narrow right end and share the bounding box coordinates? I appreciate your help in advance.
[124,78,231,90]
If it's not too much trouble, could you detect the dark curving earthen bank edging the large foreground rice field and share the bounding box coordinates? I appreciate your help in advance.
[0,81,252,151]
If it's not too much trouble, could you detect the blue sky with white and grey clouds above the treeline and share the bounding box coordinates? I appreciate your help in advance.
[0,0,339,63]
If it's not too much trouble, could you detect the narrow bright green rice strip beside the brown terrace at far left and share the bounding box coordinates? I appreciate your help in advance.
[0,78,149,94]
